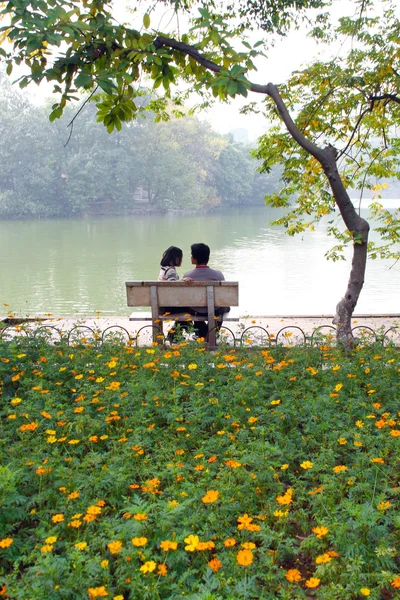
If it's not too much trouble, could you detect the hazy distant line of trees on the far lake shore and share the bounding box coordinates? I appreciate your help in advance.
[0,75,279,218]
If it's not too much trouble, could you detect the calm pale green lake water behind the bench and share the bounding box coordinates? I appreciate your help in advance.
[0,207,400,316]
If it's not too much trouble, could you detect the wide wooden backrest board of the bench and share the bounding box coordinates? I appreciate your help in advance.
[125,281,239,307]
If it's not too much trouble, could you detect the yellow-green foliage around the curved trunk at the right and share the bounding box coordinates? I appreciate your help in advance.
[256,1,400,259]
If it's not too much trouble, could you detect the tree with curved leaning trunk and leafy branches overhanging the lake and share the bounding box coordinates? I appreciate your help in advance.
[2,0,400,341]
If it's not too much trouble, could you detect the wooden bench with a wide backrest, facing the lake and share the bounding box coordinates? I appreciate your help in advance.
[125,281,239,347]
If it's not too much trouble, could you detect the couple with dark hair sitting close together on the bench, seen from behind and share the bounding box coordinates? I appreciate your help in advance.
[158,244,230,342]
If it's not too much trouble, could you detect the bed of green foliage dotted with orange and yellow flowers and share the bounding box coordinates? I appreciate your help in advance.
[0,339,400,600]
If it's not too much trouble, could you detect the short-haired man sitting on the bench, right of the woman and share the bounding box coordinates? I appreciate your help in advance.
[183,244,230,338]
